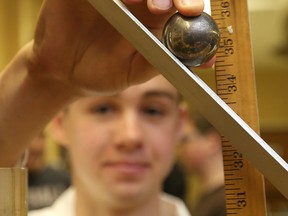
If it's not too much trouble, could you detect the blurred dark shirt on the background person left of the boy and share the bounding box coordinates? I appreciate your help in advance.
[28,167,71,210]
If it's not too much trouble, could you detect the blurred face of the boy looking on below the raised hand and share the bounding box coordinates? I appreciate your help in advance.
[53,76,184,204]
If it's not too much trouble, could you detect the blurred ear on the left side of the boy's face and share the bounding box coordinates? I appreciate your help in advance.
[50,111,68,147]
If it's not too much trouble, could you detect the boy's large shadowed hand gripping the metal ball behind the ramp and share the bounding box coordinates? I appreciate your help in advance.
[30,0,203,93]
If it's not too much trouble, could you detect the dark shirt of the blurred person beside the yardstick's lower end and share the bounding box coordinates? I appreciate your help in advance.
[191,186,226,216]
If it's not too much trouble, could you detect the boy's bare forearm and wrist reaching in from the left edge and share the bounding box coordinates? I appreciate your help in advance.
[0,43,73,167]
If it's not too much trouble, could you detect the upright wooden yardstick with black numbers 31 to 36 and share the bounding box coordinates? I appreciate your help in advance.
[211,0,266,216]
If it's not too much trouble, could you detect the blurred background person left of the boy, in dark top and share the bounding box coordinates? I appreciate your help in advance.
[26,131,71,210]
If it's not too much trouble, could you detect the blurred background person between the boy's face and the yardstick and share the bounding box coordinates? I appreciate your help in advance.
[179,113,226,216]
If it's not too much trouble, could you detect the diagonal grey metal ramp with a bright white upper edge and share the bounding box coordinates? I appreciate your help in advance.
[88,0,288,199]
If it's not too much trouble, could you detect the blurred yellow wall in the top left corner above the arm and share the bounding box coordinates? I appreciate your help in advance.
[0,0,42,70]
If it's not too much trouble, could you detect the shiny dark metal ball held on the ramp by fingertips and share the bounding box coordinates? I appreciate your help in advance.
[163,12,220,67]
